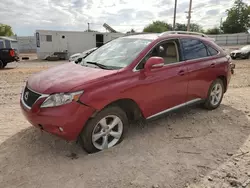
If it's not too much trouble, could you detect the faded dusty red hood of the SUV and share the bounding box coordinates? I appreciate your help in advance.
[27,63,117,94]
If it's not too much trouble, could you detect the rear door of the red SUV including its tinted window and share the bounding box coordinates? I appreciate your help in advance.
[180,38,218,101]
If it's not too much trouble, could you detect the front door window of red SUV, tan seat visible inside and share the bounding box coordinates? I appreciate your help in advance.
[137,41,180,70]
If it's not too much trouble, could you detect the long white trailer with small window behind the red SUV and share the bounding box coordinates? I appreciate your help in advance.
[35,30,125,59]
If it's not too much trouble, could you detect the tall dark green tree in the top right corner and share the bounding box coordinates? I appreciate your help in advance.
[221,0,250,33]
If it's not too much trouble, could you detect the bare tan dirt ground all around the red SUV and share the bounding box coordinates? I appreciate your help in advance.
[0,57,250,188]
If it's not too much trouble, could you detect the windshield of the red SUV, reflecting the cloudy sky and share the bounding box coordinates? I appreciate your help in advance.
[81,38,151,69]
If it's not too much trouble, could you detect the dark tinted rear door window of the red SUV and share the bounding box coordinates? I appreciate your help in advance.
[181,39,209,60]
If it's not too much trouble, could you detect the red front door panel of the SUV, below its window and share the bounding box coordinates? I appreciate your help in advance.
[127,63,188,117]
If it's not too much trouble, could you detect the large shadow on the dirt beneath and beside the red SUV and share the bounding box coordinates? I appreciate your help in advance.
[0,105,250,188]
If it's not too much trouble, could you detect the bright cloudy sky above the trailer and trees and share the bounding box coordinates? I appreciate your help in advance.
[0,0,250,36]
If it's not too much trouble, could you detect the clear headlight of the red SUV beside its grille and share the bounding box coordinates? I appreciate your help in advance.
[41,91,83,108]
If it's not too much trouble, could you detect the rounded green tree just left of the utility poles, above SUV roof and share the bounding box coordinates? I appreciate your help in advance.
[143,21,172,33]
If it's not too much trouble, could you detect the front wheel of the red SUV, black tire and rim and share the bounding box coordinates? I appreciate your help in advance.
[79,106,128,153]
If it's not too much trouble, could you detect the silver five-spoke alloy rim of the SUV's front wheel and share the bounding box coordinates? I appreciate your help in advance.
[92,115,123,150]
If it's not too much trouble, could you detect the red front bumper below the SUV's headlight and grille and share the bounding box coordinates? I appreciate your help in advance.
[20,100,95,141]
